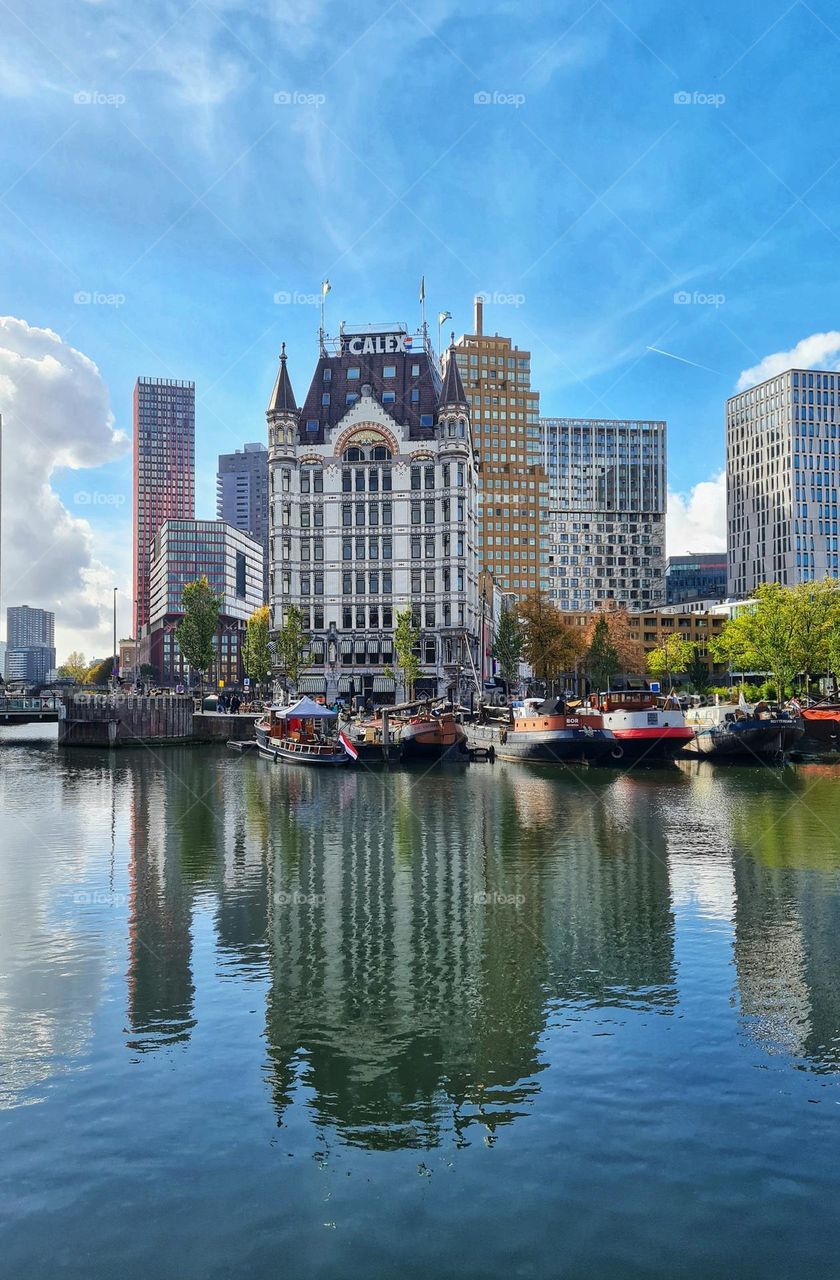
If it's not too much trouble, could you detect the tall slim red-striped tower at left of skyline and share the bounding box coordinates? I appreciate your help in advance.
[133,378,196,636]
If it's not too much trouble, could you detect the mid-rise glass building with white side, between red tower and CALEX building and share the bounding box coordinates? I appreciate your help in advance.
[138,520,263,685]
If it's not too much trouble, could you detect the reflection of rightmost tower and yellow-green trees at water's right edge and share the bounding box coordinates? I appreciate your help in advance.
[735,776,840,1071]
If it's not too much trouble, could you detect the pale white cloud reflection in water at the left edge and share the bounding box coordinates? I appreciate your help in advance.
[0,745,117,1106]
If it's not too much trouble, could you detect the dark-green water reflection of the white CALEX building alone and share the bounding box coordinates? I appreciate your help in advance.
[262,769,547,1146]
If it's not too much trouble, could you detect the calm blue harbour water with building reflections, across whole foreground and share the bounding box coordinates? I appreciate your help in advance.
[0,727,840,1280]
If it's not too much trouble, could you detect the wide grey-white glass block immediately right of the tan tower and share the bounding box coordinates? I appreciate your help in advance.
[540,417,667,609]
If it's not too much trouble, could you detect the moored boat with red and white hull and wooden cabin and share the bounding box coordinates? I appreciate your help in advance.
[581,690,694,765]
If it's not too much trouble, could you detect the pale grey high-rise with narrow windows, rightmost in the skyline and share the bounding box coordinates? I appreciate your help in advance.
[726,369,840,596]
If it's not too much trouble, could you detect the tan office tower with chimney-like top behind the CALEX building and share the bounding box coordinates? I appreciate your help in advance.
[455,294,548,596]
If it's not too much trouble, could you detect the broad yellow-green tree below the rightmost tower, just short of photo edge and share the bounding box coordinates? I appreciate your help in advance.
[709,582,802,701]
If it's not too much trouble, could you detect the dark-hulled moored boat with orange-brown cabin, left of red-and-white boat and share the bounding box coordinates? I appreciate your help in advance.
[467,698,622,764]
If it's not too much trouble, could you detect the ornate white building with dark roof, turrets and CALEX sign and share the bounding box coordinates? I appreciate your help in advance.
[266,325,478,701]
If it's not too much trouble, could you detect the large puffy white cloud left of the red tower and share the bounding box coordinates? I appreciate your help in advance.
[0,316,129,660]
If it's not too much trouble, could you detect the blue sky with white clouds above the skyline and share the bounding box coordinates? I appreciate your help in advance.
[0,0,840,659]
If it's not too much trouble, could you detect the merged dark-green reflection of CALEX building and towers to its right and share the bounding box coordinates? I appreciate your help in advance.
[258,767,674,1146]
